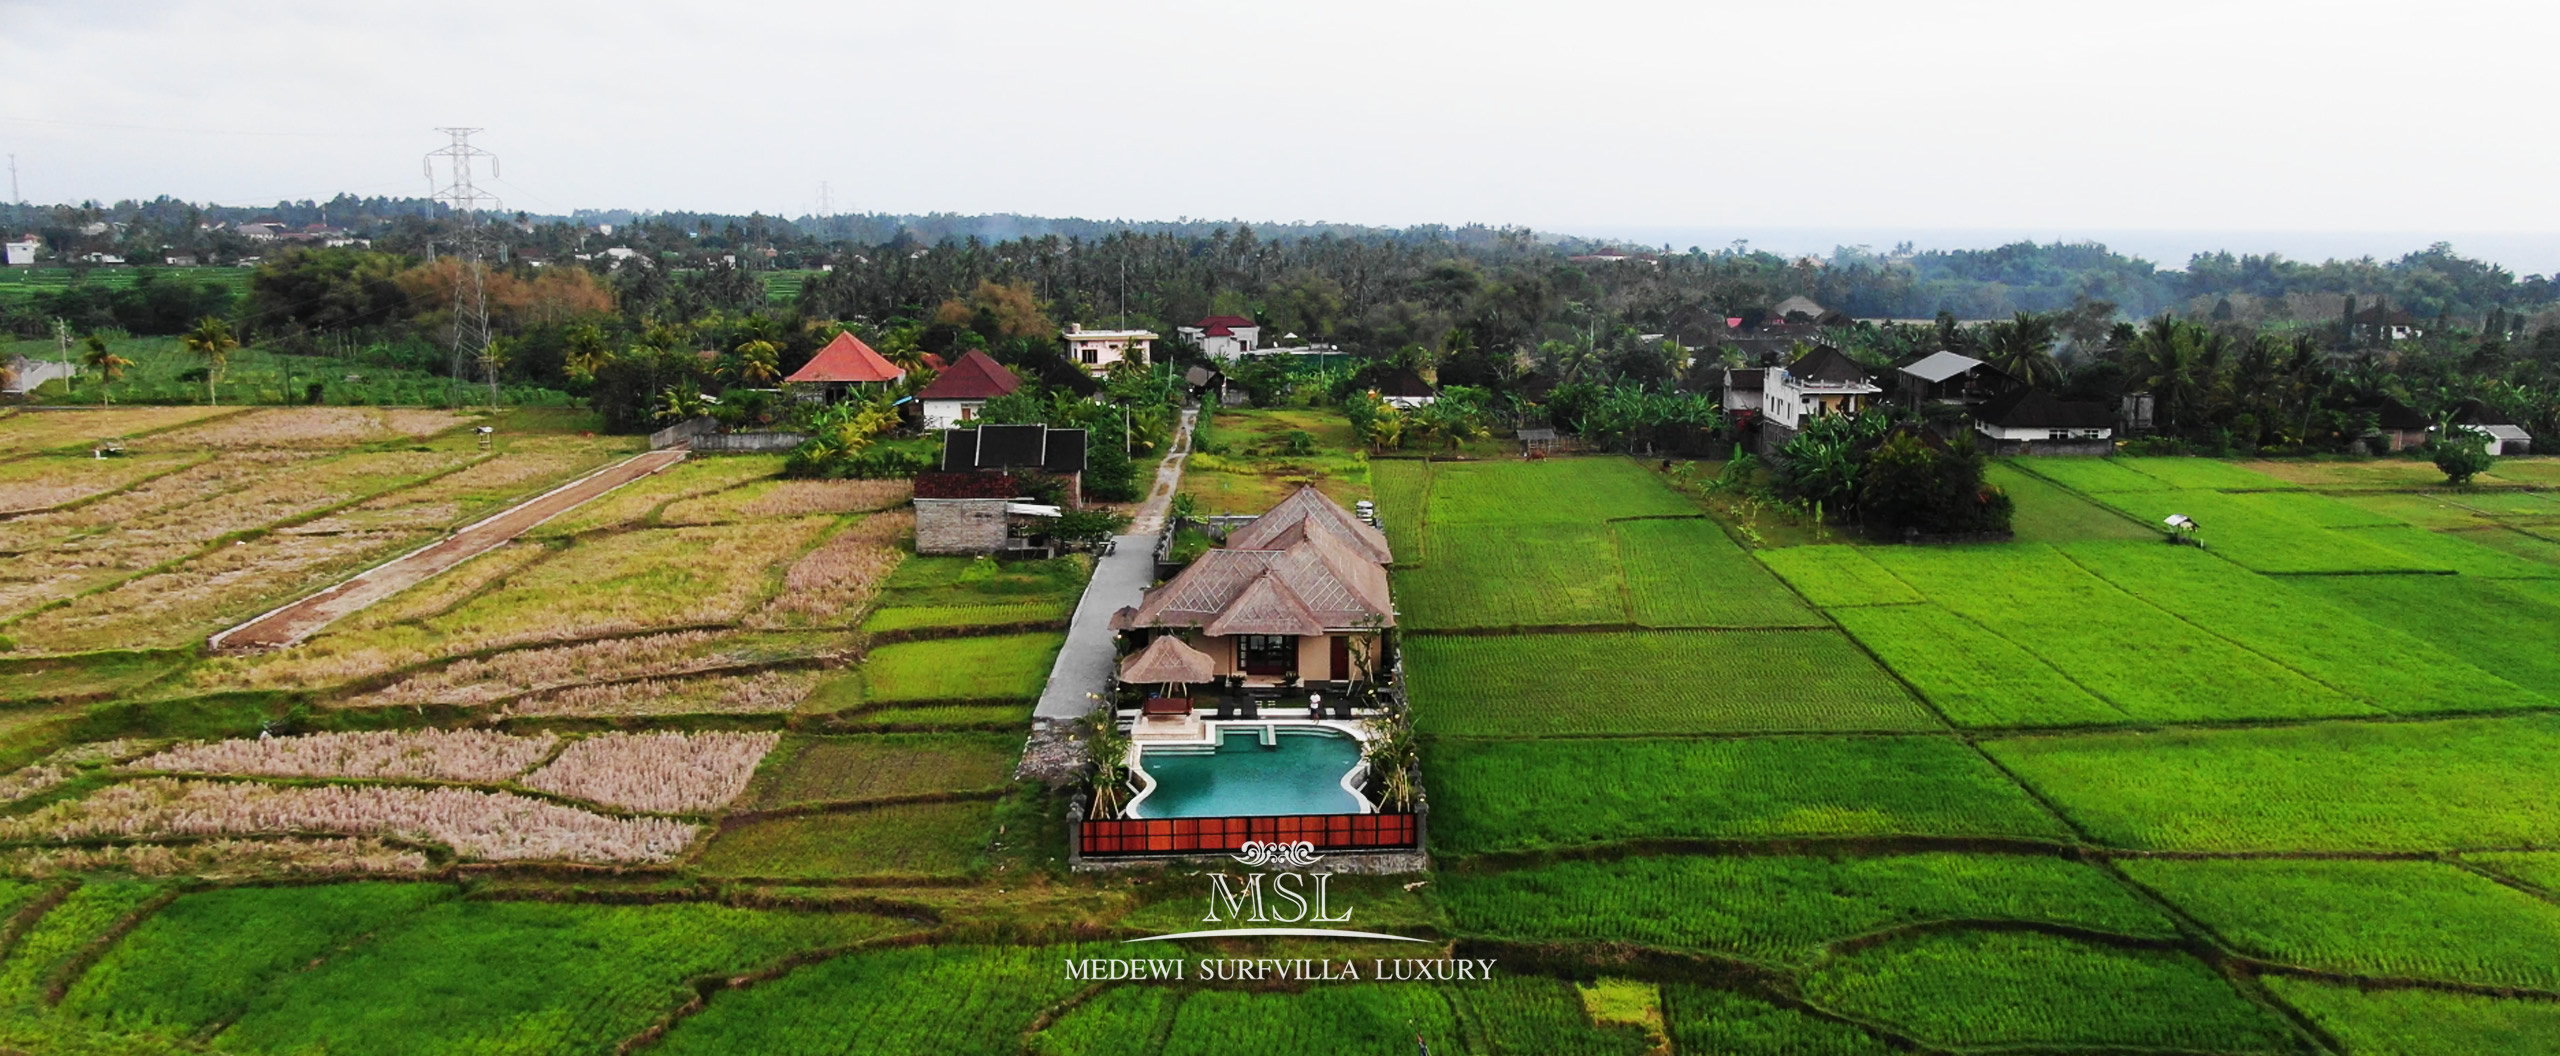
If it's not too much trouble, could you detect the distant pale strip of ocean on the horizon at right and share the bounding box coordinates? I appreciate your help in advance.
[1541,223,2560,277]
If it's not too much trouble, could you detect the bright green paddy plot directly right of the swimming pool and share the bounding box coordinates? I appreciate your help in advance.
[1423,736,2066,854]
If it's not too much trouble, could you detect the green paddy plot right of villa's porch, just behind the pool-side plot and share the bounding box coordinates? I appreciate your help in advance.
[1405,631,1940,736]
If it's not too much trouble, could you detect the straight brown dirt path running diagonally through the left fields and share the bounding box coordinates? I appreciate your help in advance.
[207,449,686,651]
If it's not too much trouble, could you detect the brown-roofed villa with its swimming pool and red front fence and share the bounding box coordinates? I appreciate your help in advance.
[1068,487,1426,869]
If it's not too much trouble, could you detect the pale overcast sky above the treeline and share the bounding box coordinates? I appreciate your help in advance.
[0,0,2560,272]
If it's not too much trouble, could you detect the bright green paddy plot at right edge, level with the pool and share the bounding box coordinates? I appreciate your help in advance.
[1984,715,2560,851]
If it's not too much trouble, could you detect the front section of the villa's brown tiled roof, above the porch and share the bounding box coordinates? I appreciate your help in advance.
[1126,531,1395,636]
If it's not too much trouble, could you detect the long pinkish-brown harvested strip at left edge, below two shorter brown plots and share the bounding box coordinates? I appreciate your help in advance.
[0,777,694,864]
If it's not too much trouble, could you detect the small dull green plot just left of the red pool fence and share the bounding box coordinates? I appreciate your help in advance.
[696,802,996,879]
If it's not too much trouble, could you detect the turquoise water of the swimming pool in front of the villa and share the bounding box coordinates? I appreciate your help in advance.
[1137,725,1359,818]
